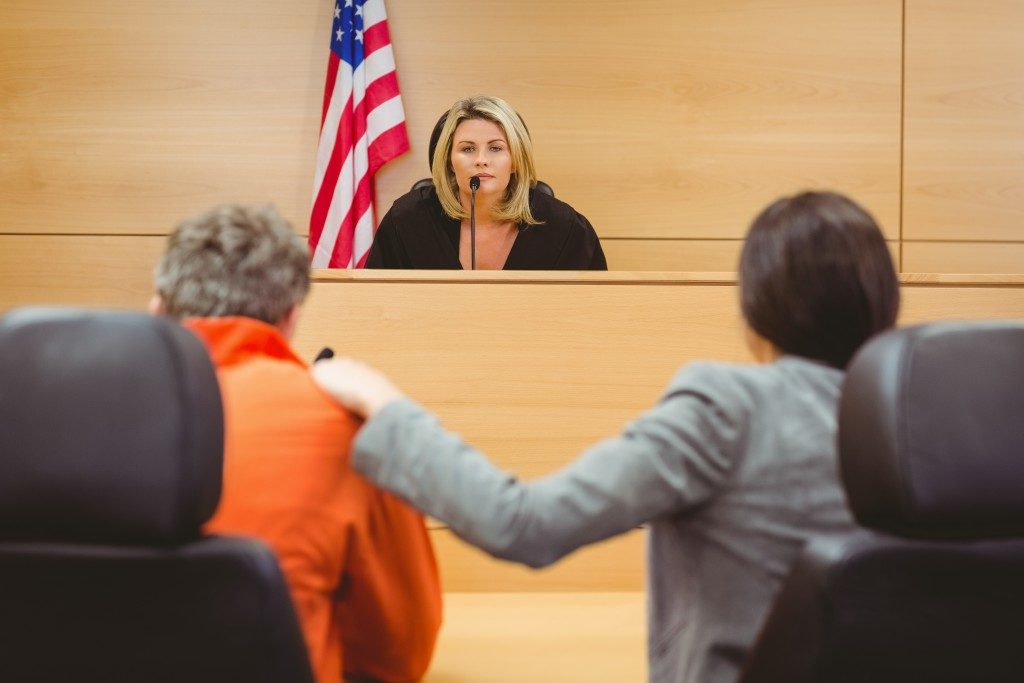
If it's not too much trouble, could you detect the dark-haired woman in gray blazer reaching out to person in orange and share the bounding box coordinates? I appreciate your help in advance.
[312,191,899,683]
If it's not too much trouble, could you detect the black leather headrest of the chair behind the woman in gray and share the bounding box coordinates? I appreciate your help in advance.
[839,322,1024,539]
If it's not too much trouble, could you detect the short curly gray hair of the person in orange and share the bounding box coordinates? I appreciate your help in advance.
[156,204,309,325]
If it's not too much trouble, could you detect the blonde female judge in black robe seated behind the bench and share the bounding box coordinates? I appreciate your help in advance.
[366,95,607,270]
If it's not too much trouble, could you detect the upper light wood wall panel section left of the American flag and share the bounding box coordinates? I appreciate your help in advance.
[0,0,323,234]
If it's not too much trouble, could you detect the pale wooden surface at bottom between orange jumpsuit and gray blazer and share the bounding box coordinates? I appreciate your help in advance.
[424,592,647,683]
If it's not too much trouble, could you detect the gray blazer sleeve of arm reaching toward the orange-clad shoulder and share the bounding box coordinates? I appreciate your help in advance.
[353,370,743,567]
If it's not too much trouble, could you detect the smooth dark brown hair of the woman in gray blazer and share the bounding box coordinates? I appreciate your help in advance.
[739,191,899,368]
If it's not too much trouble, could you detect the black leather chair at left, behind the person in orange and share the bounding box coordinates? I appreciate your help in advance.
[0,308,312,683]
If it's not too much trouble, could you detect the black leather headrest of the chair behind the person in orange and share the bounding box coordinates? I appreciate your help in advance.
[0,308,223,545]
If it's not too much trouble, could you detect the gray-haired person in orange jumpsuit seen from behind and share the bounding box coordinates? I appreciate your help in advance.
[151,206,441,683]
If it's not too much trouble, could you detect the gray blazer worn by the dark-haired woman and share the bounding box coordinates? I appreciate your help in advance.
[354,356,852,683]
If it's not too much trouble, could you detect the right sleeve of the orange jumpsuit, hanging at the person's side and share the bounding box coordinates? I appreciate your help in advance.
[336,483,441,683]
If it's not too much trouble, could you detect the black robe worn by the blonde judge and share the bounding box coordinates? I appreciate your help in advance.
[366,185,608,270]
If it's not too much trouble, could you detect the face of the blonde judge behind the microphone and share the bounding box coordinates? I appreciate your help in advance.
[452,119,512,199]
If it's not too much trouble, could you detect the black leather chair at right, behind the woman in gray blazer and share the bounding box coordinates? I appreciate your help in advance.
[741,323,1024,683]
